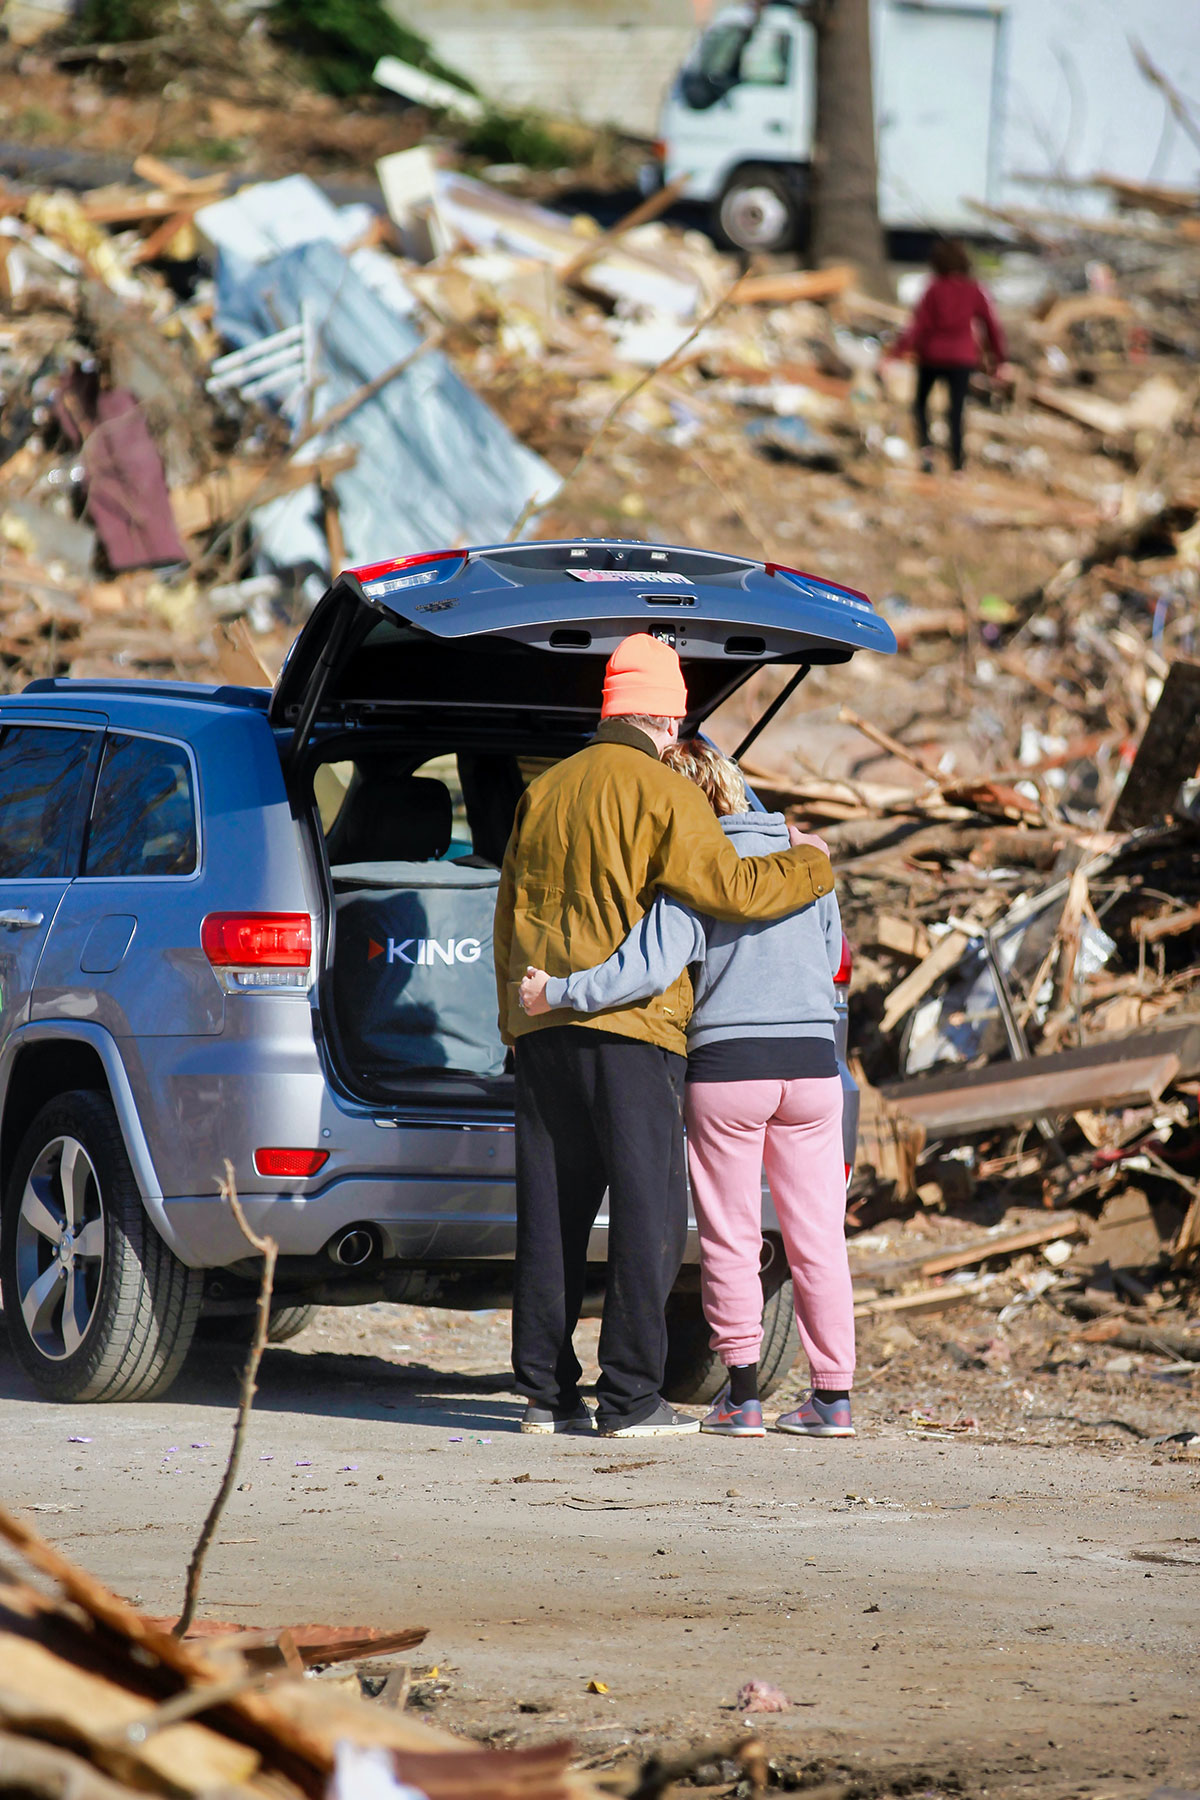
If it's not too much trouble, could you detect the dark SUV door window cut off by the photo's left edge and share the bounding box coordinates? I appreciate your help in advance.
[0,725,97,880]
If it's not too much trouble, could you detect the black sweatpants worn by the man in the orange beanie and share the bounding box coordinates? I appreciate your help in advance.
[513,1026,687,1424]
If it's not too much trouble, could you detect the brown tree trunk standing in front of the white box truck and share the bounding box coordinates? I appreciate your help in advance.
[811,0,892,297]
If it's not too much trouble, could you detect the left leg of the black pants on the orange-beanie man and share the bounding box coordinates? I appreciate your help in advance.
[513,1026,608,1411]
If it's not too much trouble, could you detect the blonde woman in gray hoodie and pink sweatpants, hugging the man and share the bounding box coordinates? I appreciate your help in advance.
[520,738,855,1438]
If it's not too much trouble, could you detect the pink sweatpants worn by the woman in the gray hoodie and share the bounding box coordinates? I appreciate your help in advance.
[685,1076,855,1388]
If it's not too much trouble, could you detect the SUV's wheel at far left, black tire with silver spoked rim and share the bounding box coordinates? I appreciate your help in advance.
[0,1091,203,1400]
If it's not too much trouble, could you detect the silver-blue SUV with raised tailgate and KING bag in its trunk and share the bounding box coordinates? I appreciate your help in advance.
[0,542,894,1400]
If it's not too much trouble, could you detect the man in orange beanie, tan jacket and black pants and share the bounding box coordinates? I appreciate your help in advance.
[495,632,833,1436]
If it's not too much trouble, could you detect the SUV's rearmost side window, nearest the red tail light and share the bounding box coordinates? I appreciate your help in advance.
[83,733,196,875]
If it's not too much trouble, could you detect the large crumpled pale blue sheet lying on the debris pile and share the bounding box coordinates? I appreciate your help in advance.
[216,239,560,601]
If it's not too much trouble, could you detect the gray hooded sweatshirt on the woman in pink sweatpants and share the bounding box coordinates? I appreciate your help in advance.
[545,812,842,1053]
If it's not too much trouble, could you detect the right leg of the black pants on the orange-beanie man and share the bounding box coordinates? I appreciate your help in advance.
[596,1033,687,1424]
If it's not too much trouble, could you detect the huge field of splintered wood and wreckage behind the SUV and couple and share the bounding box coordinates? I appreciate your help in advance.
[0,130,1200,1353]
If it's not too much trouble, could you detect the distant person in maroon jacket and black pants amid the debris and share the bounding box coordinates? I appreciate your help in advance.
[891,238,1004,472]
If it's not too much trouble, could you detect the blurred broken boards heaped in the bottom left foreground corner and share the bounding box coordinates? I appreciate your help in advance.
[0,1512,597,1800]
